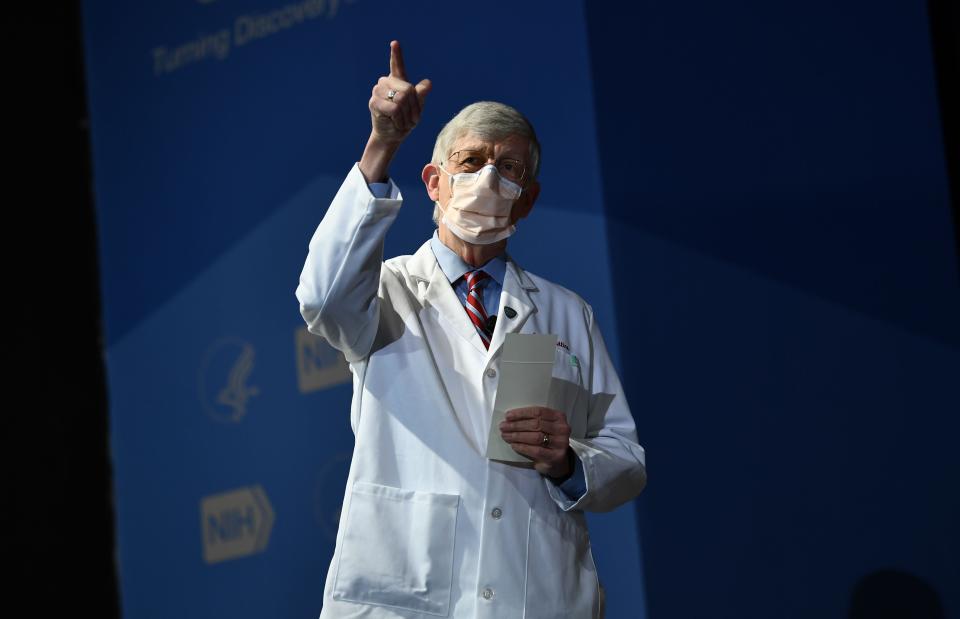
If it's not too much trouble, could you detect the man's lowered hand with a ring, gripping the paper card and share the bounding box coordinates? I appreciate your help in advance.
[500,406,572,479]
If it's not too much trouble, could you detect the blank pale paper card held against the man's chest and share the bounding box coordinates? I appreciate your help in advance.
[487,333,557,462]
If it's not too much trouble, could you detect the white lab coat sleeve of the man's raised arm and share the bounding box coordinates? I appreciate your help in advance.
[297,165,402,362]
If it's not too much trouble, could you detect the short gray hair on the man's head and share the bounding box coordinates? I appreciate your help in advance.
[432,101,540,223]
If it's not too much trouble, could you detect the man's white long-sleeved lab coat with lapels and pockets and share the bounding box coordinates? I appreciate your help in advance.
[297,166,646,619]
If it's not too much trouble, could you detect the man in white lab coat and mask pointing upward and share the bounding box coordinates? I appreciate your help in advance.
[297,41,646,619]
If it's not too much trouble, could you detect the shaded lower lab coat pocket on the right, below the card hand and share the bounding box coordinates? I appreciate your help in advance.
[523,510,600,619]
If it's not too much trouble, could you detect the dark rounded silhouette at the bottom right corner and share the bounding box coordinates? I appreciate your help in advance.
[848,570,946,619]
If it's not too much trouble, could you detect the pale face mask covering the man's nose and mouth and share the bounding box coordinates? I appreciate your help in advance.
[438,165,523,245]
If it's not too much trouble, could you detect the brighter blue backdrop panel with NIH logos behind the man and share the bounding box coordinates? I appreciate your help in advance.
[84,0,645,617]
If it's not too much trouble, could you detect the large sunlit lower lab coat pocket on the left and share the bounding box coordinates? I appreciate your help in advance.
[333,482,460,617]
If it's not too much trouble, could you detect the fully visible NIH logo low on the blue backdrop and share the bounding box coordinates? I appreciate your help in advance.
[200,484,273,563]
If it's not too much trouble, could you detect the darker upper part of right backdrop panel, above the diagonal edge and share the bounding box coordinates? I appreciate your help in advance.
[587,0,960,349]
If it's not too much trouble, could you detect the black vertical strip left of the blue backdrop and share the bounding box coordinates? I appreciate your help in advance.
[2,2,120,619]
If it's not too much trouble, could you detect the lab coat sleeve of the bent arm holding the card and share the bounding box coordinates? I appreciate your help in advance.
[547,306,647,512]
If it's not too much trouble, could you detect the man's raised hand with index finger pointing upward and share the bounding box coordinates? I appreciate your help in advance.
[369,41,430,145]
